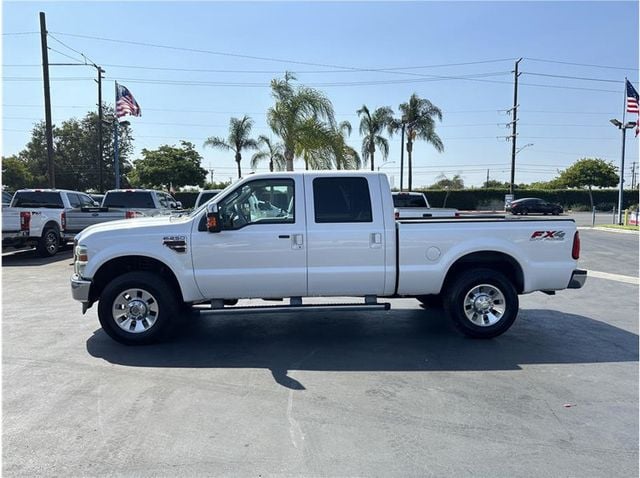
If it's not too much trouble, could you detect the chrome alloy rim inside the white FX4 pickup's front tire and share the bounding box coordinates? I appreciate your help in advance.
[111,288,158,334]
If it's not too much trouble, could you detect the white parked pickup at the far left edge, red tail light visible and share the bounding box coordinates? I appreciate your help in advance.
[2,189,95,257]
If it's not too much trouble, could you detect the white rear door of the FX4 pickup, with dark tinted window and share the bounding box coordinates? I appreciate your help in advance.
[305,175,386,296]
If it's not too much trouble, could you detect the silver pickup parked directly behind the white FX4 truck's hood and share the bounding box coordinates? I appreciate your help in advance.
[67,189,181,233]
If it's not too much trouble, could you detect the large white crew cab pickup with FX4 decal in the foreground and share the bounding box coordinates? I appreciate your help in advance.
[71,172,586,344]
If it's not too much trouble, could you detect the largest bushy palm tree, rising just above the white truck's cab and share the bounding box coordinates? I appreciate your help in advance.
[267,73,336,171]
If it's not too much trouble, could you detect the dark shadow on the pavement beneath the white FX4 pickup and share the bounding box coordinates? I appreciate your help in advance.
[87,309,638,390]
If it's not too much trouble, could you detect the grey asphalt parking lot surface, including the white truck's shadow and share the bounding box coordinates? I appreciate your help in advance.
[2,226,638,477]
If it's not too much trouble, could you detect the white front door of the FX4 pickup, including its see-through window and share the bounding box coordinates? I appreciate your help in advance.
[191,177,307,299]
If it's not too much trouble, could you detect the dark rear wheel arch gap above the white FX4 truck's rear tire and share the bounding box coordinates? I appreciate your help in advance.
[442,251,524,294]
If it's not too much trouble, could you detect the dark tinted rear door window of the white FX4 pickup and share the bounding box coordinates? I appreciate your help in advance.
[313,177,373,224]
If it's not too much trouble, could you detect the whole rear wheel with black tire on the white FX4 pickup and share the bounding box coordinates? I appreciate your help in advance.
[444,268,519,339]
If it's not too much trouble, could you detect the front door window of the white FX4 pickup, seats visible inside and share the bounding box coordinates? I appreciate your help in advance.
[218,179,295,229]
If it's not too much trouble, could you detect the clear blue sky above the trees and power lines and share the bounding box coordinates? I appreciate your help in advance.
[2,1,640,188]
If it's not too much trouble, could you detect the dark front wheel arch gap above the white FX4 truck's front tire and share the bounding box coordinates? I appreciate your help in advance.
[89,255,183,302]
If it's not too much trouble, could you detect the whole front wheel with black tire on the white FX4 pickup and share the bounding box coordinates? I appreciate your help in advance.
[98,272,182,345]
